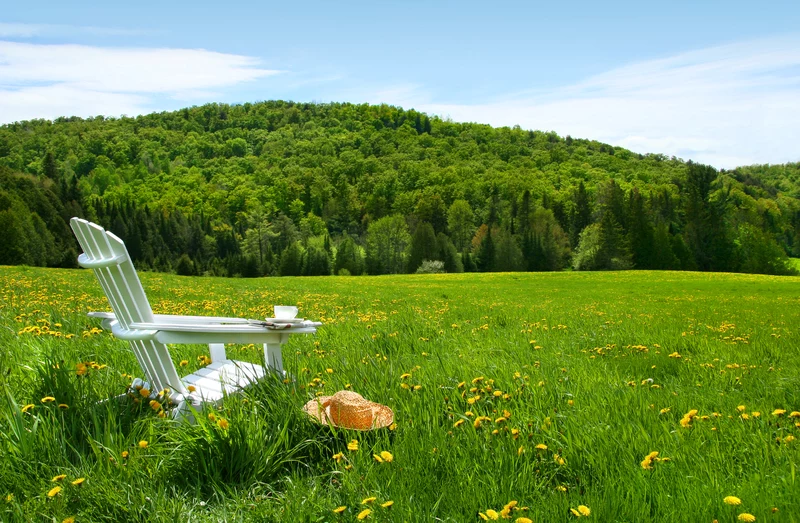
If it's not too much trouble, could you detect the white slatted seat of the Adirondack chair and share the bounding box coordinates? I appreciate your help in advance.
[182,360,265,402]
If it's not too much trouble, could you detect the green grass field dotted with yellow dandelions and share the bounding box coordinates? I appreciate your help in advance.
[0,267,800,522]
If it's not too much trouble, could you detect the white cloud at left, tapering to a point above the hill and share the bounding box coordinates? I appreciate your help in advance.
[0,41,280,123]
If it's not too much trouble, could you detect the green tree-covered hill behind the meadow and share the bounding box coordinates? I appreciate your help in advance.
[0,101,800,277]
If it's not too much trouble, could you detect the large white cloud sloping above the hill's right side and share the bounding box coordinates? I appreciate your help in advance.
[378,37,800,168]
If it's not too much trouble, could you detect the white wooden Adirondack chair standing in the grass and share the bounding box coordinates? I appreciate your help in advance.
[70,218,322,417]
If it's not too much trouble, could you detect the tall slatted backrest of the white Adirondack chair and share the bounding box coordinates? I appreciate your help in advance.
[70,218,185,393]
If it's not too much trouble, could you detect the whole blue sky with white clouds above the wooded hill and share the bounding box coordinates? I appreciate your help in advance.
[0,0,800,169]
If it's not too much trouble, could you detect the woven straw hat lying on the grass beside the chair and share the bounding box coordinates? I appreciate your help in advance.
[303,390,394,430]
